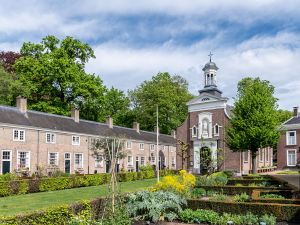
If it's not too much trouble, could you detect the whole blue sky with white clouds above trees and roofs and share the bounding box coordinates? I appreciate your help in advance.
[0,0,300,110]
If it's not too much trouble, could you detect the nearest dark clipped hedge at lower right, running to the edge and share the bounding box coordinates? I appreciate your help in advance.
[188,199,300,222]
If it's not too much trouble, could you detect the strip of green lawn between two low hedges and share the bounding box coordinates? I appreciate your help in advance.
[0,179,156,216]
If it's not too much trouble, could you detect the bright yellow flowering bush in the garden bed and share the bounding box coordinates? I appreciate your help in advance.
[152,170,196,196]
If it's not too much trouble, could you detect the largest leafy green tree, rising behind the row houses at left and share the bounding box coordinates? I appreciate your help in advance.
[14,36,106,120]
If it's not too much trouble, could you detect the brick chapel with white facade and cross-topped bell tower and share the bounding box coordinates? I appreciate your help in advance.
[176,58,273,174]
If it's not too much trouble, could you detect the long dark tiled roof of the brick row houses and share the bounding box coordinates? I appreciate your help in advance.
[0,106,176,145]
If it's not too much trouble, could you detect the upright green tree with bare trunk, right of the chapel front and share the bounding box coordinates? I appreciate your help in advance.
[226,77,279,173]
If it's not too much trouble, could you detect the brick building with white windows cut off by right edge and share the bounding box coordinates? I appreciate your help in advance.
[277,107,300,169]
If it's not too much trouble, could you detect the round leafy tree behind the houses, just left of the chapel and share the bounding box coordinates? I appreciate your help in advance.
[129,73,193,134]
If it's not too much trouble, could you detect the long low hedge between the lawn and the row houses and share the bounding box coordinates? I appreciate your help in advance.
[0,170,177,197]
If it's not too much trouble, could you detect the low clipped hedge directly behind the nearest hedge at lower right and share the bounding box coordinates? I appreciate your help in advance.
[197,185,286,195]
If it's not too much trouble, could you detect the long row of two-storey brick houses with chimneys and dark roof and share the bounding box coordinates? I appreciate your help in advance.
[0,97,176,174]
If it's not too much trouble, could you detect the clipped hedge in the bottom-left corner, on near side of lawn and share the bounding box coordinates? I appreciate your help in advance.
[0,198,104,225]
